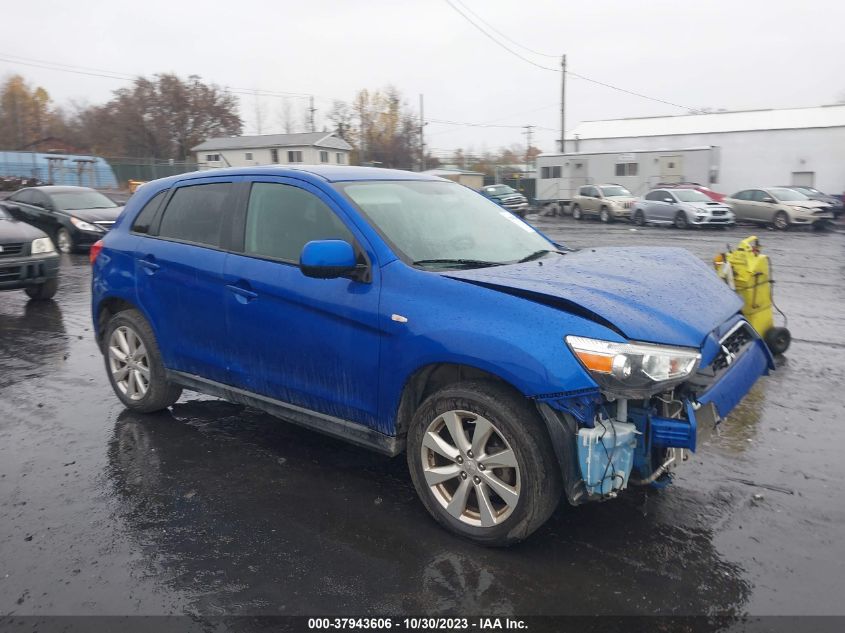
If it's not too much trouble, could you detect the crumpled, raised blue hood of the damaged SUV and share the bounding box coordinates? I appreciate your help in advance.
[444,247,742,348]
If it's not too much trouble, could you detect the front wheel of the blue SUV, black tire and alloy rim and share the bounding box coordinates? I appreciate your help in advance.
[407,381,561,546]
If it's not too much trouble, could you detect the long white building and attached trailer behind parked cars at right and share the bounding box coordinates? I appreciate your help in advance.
[537,104,845,200]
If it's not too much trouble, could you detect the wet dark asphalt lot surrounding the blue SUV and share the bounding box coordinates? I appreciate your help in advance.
[0,217,845,616]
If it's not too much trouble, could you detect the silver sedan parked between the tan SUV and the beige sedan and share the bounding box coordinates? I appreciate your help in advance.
[632,189,736,229]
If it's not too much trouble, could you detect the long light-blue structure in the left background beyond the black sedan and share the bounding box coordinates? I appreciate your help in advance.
[0,152,117,189]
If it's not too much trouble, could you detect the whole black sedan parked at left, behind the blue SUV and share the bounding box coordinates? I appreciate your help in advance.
[4,186,123,253]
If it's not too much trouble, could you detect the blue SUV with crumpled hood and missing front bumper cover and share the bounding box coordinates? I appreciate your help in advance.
[91,166,773,545]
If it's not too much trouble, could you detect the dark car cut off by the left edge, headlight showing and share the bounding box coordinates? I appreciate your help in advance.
[0,205,59,299]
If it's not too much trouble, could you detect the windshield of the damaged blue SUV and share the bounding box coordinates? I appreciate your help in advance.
[337,181,556,268]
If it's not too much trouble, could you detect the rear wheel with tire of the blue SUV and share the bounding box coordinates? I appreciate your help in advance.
[103,310,182,413]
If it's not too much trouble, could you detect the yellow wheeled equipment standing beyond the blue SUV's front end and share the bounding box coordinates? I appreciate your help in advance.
[713,235,792,355]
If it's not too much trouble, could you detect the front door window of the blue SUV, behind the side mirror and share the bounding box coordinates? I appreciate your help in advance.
[244,182,354,263]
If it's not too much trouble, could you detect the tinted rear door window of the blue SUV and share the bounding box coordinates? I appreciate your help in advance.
[158,182,233,248]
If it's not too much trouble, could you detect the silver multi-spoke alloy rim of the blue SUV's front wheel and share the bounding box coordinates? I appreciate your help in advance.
[420,410,521,527]
